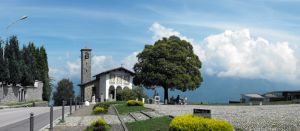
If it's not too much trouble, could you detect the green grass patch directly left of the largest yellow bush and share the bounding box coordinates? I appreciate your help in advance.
[126,116,172,131]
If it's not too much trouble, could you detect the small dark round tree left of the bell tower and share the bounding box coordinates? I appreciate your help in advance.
[53,79,74,105]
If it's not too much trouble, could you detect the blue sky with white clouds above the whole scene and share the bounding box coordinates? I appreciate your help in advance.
[0,0,300,102]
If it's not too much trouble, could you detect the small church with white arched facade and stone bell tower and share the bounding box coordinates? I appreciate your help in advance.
[79,48,134,102]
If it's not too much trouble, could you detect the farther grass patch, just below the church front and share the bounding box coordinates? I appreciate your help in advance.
[115,103,151,114]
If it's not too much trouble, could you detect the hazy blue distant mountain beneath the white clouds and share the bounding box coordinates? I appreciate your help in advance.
[64,74,300,103]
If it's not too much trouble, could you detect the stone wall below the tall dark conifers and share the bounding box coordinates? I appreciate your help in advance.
[0,81,43,103]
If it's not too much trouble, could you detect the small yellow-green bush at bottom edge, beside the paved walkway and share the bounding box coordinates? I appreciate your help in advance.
[85,119,110,131]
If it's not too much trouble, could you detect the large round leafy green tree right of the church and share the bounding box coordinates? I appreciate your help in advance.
[133,36,203,100]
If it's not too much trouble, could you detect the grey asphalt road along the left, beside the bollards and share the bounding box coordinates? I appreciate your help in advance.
[0,106,74,131]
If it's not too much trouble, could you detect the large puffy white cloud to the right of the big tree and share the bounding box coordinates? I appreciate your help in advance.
[150,23,300,82]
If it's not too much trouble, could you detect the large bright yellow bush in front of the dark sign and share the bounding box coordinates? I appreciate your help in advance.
[170,114,233,131]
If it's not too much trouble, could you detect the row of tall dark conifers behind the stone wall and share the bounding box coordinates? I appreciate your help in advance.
[0,36,51,101]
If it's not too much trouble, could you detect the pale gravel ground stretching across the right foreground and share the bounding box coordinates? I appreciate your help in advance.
[145,104,300,131]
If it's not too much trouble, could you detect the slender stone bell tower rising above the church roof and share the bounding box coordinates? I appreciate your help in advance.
[80,48,92,84]
